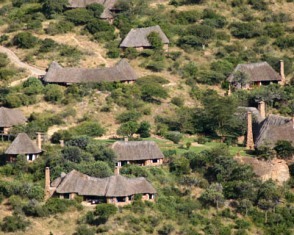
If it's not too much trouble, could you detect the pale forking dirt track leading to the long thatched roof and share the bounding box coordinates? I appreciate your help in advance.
[0,46,46,86]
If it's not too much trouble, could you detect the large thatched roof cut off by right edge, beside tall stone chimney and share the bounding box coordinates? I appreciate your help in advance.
[254,115,294,148]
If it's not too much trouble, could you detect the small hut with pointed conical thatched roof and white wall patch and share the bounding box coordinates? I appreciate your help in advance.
[5,133,42,162]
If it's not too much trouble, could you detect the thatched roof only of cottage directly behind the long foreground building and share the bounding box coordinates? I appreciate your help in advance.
[112,141,164,161]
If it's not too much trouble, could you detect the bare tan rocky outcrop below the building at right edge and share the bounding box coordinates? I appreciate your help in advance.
[234,156,290,185]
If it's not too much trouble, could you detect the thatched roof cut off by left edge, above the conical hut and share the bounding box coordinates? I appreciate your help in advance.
[0,107,26,127]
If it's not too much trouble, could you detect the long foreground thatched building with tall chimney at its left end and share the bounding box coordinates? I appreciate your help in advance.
[45,167,156,206]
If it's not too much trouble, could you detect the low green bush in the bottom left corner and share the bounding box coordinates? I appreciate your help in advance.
[1,215,30,232]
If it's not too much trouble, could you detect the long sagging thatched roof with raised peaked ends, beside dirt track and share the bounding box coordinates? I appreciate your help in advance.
[43,59,138,84]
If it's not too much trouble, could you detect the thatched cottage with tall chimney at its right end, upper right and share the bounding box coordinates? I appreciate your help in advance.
[227,61,285,89]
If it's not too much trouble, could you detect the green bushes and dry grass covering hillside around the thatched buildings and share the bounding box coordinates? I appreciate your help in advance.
[0,0,294,235]
